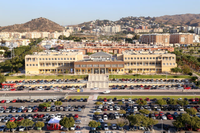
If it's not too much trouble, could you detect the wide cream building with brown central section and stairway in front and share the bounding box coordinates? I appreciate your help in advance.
[25,50,177,74]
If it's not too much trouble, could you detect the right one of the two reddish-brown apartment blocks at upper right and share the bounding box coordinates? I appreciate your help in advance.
[170,33,193,44]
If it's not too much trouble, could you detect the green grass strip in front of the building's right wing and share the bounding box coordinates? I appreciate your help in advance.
[109,75,191,79]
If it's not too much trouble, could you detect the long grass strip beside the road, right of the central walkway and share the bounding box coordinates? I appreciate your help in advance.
[98,96,197,99]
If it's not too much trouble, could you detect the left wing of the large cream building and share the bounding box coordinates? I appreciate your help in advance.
[25,50,83,74]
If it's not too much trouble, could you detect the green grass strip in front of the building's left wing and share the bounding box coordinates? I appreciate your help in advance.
[6,75,87,80]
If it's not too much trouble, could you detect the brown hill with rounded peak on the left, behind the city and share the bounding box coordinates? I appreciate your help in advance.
[0,17,64,32]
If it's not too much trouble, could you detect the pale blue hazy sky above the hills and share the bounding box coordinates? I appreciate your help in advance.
[0,0,200,26]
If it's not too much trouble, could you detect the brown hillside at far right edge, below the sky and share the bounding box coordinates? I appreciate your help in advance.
[154,14,200,26]
